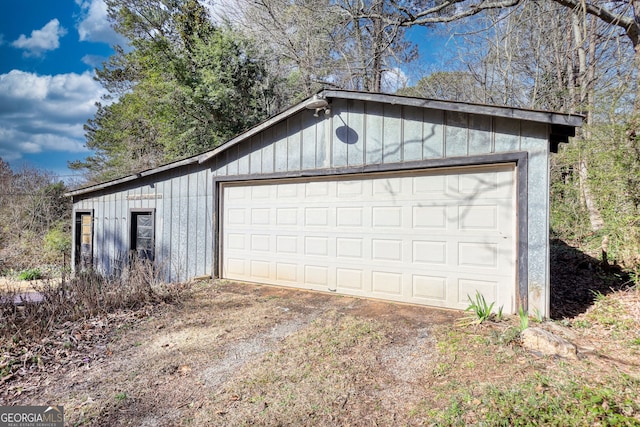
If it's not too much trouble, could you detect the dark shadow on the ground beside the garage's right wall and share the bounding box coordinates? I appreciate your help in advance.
[551,239,632,320]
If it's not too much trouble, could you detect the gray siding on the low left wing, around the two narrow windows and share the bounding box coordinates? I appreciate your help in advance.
[74,167,213,281]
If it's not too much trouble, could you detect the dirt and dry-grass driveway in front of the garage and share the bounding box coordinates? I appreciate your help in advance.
[0,281,640,426]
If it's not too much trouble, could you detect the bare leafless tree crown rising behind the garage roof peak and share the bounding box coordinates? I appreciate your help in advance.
[231,0,417,96]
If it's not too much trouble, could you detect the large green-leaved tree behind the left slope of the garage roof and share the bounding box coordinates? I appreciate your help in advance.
[70,0,272,181]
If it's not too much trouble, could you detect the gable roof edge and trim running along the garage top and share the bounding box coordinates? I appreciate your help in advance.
[65,90,584,196]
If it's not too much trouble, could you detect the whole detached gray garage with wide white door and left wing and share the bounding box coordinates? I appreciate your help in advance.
[70,90,582,315]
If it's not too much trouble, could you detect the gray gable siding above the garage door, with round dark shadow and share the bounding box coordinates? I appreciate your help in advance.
[210,99,549,176]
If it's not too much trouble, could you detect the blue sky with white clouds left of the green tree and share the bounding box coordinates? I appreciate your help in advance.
[0,0,121,178]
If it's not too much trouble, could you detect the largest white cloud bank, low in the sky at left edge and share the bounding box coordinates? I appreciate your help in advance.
[0,70,105,161]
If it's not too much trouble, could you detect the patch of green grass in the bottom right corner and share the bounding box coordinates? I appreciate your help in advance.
[428,375,640,426]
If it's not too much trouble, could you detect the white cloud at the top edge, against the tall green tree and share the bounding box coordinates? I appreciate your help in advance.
[76,0,126,46]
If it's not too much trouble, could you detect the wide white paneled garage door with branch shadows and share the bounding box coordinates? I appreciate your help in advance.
[221,165,516,312]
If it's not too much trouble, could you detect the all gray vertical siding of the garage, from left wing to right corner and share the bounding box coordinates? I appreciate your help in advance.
[74,98,550,313]
